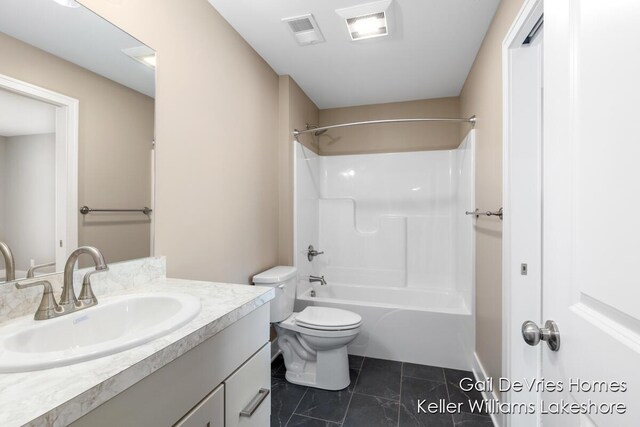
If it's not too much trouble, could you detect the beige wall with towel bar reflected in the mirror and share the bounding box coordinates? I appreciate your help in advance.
[0,33,154,262]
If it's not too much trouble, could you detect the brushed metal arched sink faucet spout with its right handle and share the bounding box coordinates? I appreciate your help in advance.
[59,246,109,311]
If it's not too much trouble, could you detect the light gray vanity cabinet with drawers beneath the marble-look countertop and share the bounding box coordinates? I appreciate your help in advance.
[71,303,271,427]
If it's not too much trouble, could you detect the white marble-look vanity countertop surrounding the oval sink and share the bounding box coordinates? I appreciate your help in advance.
[0,278,273,427]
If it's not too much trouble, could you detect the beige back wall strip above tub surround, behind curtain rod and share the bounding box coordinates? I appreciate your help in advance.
[318,97,462,155]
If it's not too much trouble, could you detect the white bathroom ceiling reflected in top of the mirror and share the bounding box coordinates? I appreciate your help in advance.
[0,0,155,97]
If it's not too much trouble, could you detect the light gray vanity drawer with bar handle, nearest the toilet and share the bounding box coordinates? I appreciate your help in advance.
[224,343,271,427]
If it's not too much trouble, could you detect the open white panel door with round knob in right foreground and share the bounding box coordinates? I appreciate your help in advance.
[532,0,640,427]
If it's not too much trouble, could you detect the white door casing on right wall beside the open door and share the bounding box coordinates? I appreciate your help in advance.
[499,0,544,427]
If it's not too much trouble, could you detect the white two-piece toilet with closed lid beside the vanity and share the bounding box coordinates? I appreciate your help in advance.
[253,266,362,390]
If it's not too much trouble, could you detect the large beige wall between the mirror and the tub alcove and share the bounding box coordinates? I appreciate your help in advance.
[81,0,278,283]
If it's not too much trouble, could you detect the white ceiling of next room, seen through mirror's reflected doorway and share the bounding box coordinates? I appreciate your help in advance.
[0,89,56,136]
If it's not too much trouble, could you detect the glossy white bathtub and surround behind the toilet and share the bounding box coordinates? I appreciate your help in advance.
[294,131,475,369]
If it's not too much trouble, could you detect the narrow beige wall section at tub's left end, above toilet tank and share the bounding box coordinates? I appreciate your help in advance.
[278,76,319,265]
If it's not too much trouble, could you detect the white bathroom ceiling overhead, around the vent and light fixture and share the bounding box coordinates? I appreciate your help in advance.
[208,0,500,109]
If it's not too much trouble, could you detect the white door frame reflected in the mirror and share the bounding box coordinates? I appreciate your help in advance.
[0,74,80,271]
